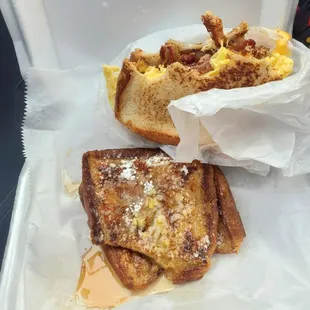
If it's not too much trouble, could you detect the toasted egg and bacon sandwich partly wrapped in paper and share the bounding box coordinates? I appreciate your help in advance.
[103,12,294,145]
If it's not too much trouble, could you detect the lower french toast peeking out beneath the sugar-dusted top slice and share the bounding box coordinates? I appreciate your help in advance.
[80,166,245,290]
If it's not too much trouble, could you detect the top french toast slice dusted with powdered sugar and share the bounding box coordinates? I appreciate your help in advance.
[83,149,218,283]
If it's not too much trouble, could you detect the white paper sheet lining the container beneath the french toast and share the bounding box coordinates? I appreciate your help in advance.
[23,26,310,310]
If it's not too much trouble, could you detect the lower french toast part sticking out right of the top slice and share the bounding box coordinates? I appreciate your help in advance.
[214,166,246,254]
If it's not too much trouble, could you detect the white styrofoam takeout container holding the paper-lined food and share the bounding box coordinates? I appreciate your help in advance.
[0,0,298,310]
